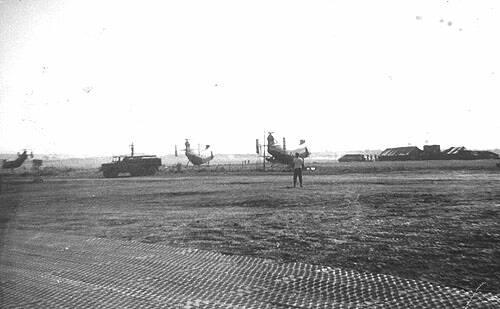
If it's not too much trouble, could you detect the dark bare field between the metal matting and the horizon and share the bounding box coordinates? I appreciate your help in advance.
[0,171,500,293]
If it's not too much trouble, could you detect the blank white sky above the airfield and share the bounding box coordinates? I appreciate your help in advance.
[0,0,500,156]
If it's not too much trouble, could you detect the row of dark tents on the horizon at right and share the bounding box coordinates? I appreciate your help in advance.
[339,145,500,162]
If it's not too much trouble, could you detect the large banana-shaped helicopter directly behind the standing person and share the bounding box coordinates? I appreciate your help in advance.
[256,132,311,166]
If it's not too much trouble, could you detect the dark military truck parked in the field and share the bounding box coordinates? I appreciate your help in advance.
[101,144,161,178]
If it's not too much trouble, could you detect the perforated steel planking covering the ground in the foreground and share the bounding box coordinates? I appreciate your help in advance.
[0,231,500,308]
